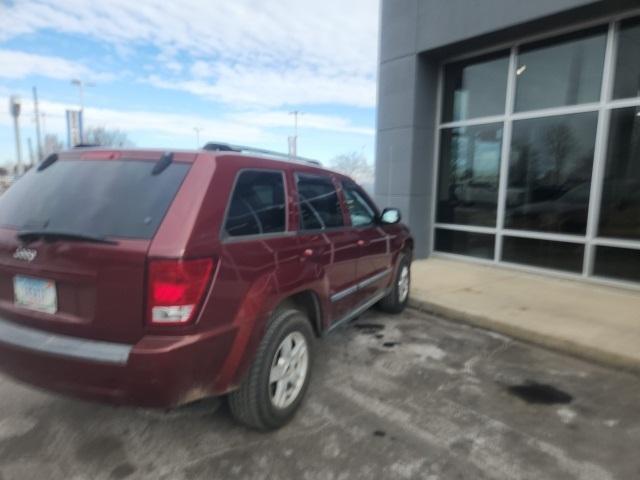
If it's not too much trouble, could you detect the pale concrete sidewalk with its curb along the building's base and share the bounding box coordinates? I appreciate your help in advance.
[410,258,640,373]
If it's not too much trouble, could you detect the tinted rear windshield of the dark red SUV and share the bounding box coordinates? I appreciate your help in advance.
[0,160,190,239]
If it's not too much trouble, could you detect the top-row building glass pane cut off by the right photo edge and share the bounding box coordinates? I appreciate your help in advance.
[613,18,640,98]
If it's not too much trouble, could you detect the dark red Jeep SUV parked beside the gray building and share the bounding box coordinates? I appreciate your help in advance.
[0,144,413,429]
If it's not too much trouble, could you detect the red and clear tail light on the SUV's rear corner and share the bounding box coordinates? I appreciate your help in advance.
[147,258,214,325]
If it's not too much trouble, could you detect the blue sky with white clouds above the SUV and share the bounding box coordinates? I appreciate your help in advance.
[0,0,379,168]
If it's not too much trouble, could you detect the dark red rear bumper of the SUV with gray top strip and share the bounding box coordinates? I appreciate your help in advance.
[0,319,236,408]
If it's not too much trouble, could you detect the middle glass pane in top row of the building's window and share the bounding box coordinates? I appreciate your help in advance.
[515,28,606,112]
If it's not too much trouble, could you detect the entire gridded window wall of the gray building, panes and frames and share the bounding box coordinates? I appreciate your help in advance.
[433,21,640,281]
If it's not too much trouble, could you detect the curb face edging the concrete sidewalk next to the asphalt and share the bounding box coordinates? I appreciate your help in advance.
[409,298,640,375]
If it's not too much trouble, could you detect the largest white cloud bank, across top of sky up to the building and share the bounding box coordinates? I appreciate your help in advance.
[0,0,378,107]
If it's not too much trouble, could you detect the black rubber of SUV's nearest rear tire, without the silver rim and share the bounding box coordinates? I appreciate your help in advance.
[228,309,315,430]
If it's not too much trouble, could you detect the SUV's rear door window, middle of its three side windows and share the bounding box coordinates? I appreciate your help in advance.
[296,174,344,230]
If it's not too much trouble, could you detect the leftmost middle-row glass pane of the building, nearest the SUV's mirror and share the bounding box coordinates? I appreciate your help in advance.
[437,124,502,227]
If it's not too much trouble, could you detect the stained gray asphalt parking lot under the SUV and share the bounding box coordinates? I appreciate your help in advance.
[0,311,640,480]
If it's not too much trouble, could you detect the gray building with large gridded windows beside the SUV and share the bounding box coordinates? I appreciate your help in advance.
[375,0,640,287]
